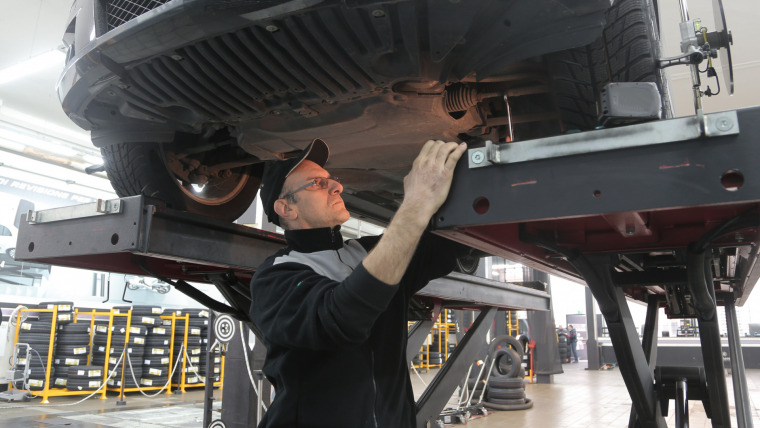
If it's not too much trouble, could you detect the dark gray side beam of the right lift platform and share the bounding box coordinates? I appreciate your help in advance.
[435,107,760,229]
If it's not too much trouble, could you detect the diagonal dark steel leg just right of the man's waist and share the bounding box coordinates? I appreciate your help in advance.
[417,308,497,428]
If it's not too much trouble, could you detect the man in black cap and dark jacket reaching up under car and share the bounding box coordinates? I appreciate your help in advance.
[250,139,467,428]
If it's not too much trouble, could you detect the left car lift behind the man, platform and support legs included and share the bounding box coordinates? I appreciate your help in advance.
[16,196,550,427]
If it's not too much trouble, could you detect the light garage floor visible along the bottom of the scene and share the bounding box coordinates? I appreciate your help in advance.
[0,361,760,428]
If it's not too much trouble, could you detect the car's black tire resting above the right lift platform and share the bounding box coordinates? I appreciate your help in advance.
[546,0,672,130]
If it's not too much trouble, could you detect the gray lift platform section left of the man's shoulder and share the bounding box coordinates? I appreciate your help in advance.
[16,196,283,270]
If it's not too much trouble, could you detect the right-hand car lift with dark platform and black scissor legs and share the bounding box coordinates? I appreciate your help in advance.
[434,107,760,427]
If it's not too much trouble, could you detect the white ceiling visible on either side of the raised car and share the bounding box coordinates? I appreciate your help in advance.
[0,0,760,163]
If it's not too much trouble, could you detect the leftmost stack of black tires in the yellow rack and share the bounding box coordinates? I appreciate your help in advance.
[13,316,56,391]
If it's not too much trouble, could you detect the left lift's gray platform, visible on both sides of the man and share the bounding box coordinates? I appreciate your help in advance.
[11,196,549,310]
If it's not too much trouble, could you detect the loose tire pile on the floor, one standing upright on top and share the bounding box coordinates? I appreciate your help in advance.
[483,335,533,410]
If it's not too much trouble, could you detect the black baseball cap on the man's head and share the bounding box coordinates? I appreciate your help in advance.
[259,138,330,226]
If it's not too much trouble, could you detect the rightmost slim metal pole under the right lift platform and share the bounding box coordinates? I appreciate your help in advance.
[723,293,752,428]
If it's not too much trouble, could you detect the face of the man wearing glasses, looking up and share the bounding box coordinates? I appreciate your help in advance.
[281,160,350,229]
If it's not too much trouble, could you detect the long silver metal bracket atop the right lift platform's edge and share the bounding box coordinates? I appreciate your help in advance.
[468,111,739,169]
